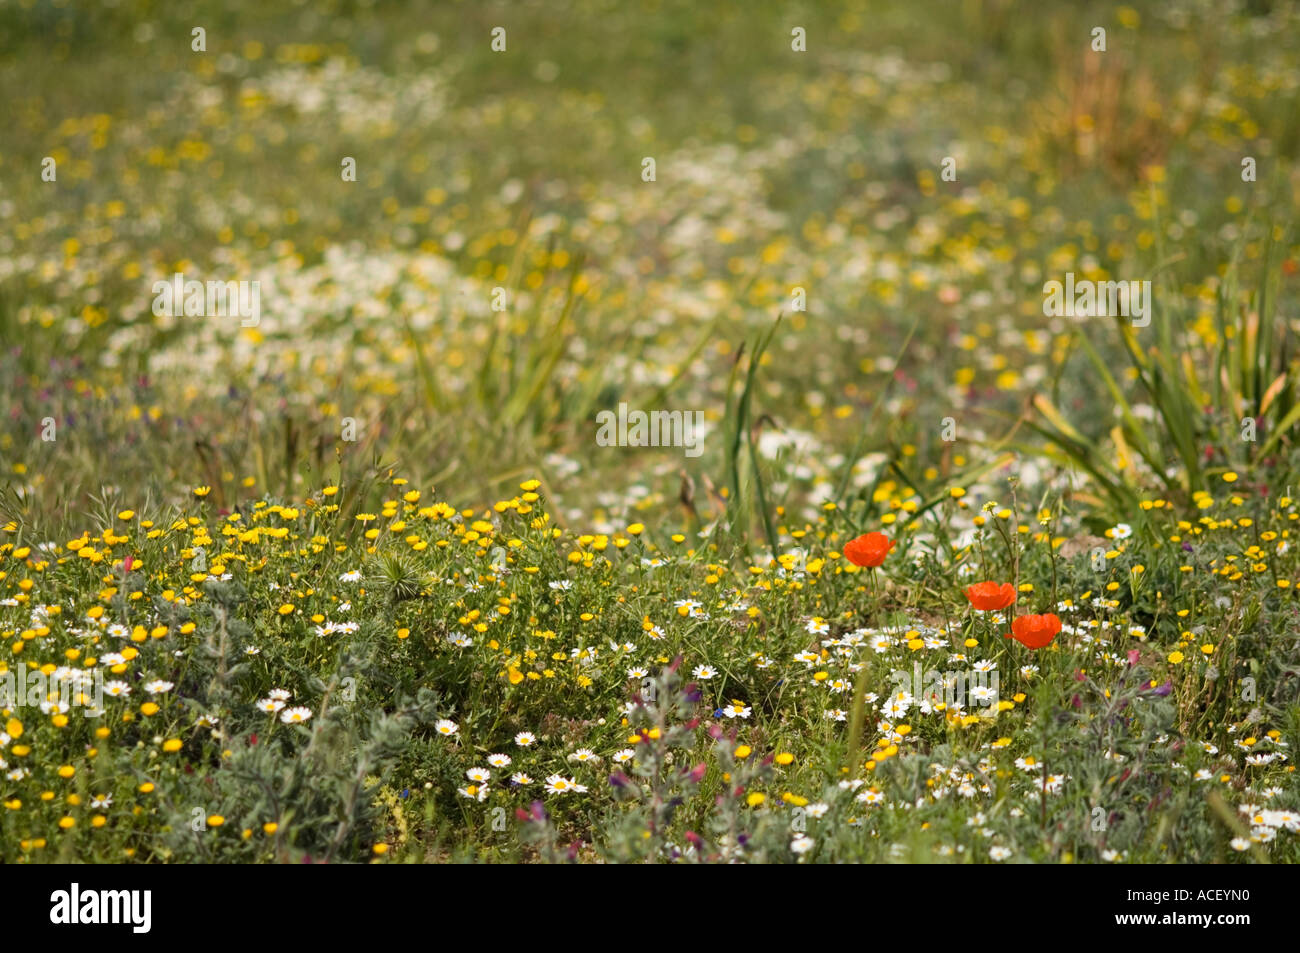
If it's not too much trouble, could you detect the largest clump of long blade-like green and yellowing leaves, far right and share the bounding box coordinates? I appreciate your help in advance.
[1027,229,1300,515]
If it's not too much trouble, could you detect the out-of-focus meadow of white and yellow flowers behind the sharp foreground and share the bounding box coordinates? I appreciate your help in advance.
[0,0,1300,529]
